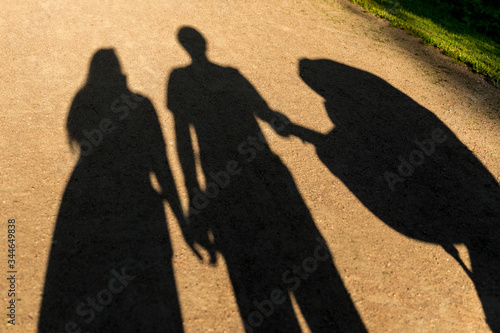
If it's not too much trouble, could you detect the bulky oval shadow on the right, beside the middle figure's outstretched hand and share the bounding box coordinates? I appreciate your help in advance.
[289,59,500,332]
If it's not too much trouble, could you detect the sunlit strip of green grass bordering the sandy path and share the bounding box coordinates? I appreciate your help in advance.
[351,0,500,87]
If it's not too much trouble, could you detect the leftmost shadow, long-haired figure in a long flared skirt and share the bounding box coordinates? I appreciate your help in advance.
[38,49,183,332]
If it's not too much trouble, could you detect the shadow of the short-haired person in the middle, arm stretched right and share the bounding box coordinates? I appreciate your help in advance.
[167,27,365,332]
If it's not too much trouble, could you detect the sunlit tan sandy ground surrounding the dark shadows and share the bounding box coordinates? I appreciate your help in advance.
[0,0,500,332]
